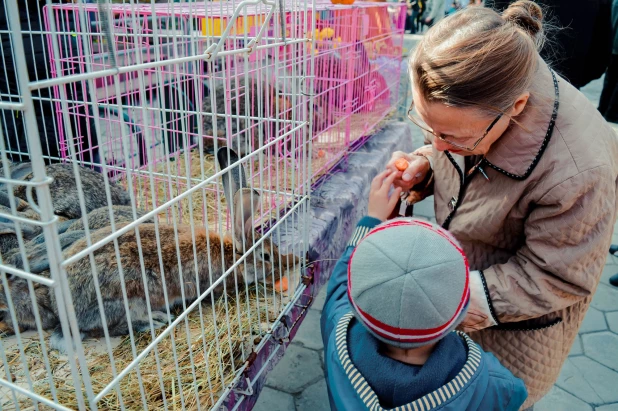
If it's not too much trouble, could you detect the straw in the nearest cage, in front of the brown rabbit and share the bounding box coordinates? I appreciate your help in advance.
[0,289,293,411]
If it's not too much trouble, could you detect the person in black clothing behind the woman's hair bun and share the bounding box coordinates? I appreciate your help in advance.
[485,0,612,89]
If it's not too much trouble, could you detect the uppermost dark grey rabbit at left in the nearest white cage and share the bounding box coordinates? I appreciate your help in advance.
[13,163,131,219]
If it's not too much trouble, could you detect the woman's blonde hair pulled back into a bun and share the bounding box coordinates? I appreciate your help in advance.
[409,0,545,114]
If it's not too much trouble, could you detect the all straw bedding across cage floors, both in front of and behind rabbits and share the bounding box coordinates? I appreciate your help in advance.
[0,107,394,410]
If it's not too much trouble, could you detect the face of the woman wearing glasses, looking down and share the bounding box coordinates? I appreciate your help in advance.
[414,83,529,156]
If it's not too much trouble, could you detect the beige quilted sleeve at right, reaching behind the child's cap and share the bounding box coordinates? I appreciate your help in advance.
[483,166,617,323]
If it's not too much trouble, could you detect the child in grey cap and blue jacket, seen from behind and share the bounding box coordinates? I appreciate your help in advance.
[321,171,527,411]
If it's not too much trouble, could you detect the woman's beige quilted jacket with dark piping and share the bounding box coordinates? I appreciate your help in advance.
[418,58,618,407]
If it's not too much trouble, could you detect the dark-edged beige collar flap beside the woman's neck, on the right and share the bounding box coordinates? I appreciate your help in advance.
[485,59,559,180]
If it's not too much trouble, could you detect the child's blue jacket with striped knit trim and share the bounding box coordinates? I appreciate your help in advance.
[321,217,528,411]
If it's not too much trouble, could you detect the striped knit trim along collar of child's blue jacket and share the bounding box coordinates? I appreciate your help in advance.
[335,312,481,411]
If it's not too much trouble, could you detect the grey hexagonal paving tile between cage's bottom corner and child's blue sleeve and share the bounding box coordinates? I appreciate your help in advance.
[266,344,324,394]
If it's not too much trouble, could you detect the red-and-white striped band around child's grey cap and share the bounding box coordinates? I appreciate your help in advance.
[348,219,470,342]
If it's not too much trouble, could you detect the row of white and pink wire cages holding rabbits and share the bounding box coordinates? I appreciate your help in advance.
[0,0,405,410]
